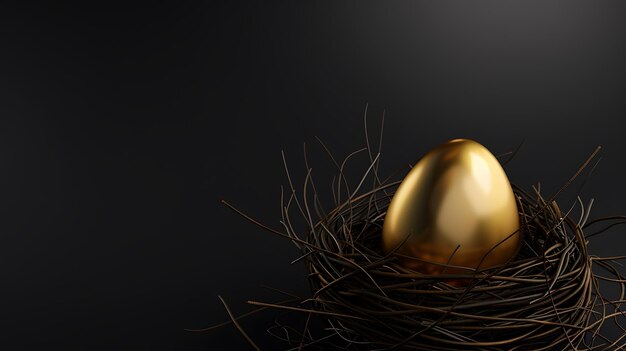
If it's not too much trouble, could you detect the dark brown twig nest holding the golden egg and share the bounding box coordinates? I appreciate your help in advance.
[211,121,626,350]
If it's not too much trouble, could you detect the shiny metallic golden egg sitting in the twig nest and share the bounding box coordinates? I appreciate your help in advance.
[382,139,521,274]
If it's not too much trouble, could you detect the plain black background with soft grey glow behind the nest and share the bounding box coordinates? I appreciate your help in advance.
[0,1,626,350]
